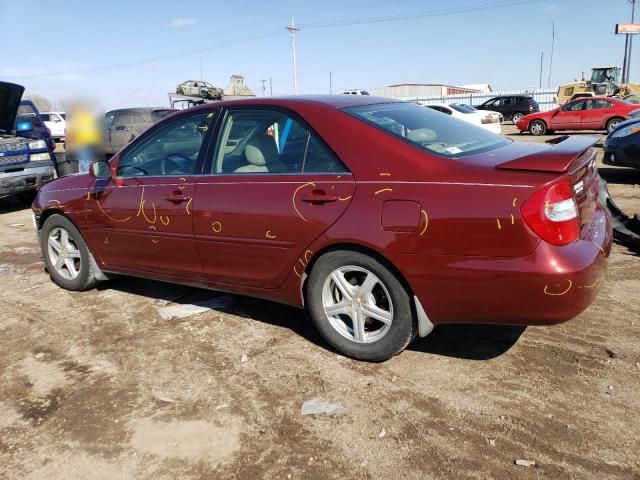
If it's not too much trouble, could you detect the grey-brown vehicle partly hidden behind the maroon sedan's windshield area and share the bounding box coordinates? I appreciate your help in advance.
[104,108,175,154]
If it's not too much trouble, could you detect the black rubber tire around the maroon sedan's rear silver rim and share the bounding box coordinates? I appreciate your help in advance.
[306,250,417,362]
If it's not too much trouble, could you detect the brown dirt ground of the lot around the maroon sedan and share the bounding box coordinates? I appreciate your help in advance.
[0,125,640,480]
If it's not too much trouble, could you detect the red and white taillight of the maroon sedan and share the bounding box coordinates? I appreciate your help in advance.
[520,177,580,245]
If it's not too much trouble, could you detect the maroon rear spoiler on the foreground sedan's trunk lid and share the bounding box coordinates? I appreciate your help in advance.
[496,135,600,173]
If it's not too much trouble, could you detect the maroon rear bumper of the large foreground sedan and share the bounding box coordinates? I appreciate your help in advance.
[391,206,612,325]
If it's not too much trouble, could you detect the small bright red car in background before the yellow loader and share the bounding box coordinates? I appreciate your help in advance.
[516,97,640,135]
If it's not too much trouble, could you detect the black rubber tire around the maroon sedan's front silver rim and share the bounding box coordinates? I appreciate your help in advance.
[40,214,98,291]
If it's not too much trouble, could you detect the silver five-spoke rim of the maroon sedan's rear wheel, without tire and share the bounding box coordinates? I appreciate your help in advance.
[322,265,393,343]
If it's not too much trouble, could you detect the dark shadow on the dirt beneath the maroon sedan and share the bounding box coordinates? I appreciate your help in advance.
[104,276,526,360]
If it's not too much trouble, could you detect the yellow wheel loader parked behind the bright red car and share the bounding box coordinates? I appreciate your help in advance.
[555,65,640,105]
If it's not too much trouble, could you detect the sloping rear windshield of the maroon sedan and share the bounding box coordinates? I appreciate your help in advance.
[344,102,510,158]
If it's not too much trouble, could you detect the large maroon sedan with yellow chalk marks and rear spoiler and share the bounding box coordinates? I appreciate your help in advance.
[33,95,612,361]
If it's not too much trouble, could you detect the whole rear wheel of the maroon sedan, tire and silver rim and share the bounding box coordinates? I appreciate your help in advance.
[307,250,417,361]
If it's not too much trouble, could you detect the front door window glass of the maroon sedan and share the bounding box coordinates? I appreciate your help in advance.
[117,111,214,177]
